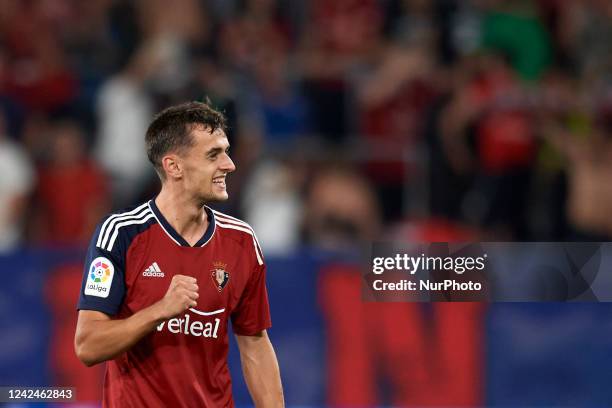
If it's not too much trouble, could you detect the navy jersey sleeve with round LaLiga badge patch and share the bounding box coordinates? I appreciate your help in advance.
[77,223,125,316]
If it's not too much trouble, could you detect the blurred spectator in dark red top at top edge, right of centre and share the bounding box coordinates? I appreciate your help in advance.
[298,0,382,143]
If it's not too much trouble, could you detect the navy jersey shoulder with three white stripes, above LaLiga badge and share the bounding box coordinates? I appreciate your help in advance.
[92,201,156,252]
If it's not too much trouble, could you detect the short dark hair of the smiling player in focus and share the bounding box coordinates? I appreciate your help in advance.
[145,102,226,178]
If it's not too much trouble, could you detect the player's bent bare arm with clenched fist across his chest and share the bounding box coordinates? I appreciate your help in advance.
[74,275,199,366]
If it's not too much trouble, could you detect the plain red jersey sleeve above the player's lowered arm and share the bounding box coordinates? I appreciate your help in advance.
[231,264,272,336]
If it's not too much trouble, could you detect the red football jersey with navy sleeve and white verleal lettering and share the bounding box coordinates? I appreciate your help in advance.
[78,200,271,407]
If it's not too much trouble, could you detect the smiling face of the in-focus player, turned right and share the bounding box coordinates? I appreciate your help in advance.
[180,126,236,202]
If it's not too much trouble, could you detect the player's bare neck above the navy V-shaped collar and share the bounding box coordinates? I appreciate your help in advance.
[155,187,208,246]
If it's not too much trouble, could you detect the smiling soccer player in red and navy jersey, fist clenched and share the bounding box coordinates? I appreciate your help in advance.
[75,102,284,407]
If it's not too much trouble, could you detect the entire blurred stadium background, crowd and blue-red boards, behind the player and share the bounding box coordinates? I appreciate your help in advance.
[0,0,612,407]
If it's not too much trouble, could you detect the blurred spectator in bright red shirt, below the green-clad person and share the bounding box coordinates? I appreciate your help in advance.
[433,55,537,239]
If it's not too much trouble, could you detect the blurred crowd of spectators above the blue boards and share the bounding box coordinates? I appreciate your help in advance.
[0,0,612,254]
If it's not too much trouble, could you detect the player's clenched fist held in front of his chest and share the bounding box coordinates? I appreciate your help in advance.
[155,275,200,320]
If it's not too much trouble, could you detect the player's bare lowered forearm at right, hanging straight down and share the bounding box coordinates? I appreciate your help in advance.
[236,330,285,408]
